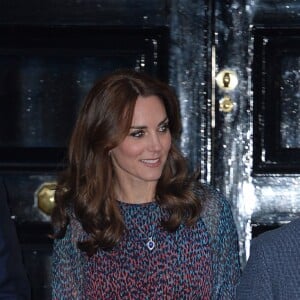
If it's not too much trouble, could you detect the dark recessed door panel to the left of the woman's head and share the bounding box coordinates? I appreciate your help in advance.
[0,55,136,148]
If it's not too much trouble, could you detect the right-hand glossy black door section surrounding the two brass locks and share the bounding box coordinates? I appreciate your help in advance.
[213,1,300,264]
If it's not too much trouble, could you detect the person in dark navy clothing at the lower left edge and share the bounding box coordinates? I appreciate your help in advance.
[0,178,30,300]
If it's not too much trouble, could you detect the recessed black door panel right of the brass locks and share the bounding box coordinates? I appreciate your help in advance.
[252,27,300,175]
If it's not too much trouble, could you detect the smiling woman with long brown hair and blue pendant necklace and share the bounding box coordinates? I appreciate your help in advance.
[53,70,239,299]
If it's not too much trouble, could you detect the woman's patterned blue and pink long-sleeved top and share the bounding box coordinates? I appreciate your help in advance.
[52,186,240,300]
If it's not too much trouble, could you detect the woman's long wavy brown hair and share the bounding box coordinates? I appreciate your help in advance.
[52,70,202,255]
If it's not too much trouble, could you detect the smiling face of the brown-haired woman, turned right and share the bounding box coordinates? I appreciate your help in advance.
[111,96,171,183]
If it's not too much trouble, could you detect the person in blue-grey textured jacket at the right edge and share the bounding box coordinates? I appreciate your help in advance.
[236,218,300,300]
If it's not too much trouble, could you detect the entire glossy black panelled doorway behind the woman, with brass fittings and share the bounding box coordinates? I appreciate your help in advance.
[0,0,300,299]
